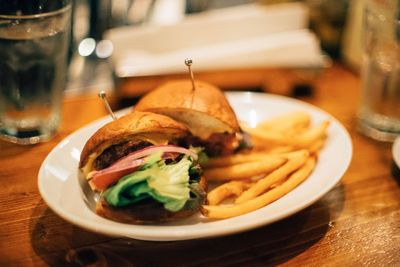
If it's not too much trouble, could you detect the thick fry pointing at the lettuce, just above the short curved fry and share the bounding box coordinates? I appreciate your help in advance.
[204,157,287,181]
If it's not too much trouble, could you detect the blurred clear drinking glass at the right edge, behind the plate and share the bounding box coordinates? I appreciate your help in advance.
[358,0,400,141]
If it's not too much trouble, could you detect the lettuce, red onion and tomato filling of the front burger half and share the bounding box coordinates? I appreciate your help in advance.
[88,146,205,212]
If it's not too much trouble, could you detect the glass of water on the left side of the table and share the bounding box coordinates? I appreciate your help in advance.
[0,0,72,144]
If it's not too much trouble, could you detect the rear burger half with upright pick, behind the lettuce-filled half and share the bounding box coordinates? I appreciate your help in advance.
[134,80,250,156]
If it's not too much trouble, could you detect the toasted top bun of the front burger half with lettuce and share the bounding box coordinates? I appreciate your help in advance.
[79,111,189,176]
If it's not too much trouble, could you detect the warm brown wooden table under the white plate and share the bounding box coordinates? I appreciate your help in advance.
[0,66,400,266]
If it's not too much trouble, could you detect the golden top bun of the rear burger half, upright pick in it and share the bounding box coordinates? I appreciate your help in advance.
[134,80,239,139]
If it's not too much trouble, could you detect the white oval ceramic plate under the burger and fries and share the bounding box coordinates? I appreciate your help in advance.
[38,92,352,241]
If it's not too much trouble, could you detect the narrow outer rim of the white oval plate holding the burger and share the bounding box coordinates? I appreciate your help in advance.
[38,92,353,241]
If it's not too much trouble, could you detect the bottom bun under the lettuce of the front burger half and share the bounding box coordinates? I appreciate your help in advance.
[96,177,207,224]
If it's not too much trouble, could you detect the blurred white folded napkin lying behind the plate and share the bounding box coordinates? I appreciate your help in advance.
[105,3,323,77]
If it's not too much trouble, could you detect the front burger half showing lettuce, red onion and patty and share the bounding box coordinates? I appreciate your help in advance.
[79,111,206,223]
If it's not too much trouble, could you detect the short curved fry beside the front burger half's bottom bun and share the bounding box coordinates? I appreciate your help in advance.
[207,181,252,205]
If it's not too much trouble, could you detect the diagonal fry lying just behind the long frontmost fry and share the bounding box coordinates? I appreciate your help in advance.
[235,150,309,203]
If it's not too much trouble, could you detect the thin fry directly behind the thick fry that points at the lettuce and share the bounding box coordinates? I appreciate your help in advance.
[203,152,286,168]
